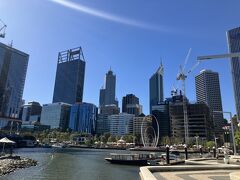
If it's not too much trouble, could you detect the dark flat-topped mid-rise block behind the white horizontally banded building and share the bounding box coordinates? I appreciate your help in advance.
[122,94,142,116]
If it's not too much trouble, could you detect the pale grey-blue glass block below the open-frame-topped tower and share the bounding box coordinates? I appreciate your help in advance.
[40,102,71,131]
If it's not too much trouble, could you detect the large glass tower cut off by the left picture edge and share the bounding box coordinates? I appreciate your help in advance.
[0,43,29,118]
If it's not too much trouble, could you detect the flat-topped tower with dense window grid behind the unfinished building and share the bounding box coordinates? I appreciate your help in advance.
[195,70,224,136]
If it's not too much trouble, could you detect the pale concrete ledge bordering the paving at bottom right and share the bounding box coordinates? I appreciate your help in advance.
[139,164,240,180]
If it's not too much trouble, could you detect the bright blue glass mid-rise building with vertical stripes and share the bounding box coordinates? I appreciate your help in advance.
[69,103,98,134]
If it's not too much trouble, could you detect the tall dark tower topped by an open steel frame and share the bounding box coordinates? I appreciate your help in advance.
[53,47,85,104]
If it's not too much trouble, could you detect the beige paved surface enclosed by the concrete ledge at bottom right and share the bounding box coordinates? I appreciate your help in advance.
[153,170,236,180]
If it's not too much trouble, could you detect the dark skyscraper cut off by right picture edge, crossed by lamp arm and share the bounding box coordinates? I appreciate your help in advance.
[227,27,240,118]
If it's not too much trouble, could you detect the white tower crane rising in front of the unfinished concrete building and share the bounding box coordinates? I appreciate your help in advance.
[177,48,199,145]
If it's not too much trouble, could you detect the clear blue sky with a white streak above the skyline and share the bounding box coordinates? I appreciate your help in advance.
[0,0,240,114]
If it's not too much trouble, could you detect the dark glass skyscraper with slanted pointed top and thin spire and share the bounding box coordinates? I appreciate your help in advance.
[149,63,164,113]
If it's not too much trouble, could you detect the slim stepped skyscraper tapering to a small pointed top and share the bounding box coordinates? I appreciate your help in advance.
[99,69,118,108]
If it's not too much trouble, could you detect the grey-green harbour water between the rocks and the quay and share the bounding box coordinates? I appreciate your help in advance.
[0,148,139,180]
